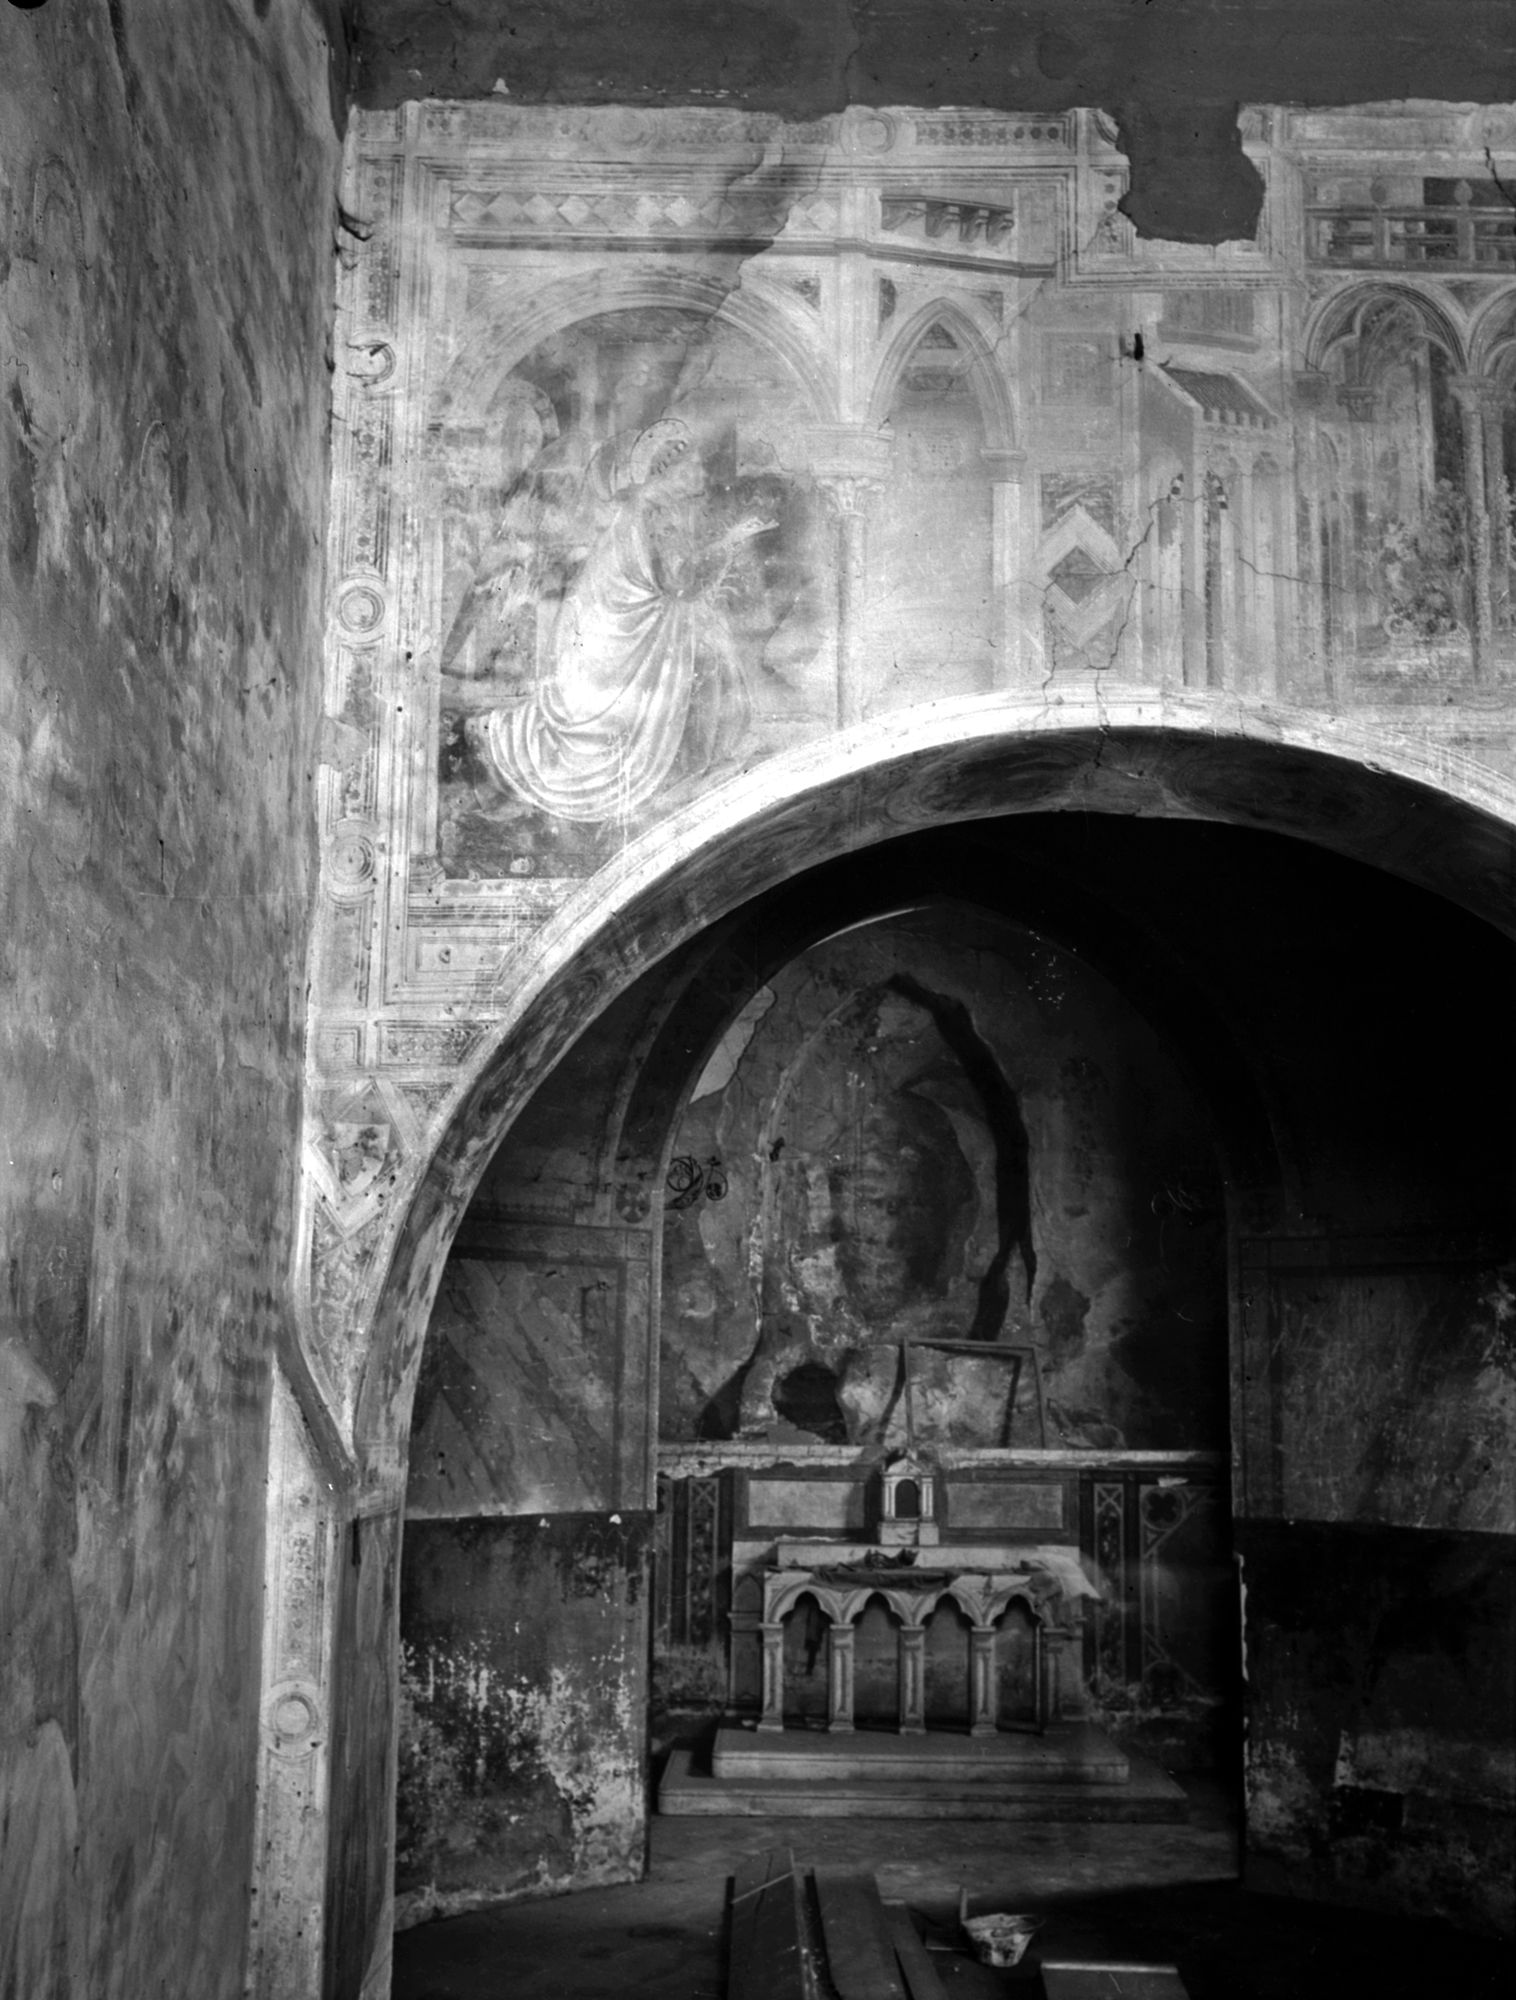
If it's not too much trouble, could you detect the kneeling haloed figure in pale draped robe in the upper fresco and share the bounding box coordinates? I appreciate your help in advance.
[466,418,778,822]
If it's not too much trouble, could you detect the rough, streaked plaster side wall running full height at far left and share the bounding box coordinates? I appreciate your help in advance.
[0,0,338,2000]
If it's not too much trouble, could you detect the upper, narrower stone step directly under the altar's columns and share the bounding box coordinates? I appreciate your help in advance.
[710,1722,1130,1786]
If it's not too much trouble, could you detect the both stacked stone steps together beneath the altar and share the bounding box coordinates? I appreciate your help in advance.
[658,1722,1188,1822]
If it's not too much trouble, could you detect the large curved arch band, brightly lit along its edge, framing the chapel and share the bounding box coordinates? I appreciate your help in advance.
[354,694,1516,1456]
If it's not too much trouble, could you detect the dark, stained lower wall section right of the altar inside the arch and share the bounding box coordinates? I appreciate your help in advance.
[1238,1520,1516,1934]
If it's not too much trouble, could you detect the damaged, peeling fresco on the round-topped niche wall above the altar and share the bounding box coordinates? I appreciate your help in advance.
[660,912,1226,1450]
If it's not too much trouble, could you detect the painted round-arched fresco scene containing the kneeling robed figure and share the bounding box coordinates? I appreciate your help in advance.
[430,306,836,878]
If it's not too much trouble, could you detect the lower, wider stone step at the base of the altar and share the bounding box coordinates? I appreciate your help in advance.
[658,1732,1190,1824]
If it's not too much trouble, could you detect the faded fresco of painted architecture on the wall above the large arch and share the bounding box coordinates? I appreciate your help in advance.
[332,104,1516,920]
